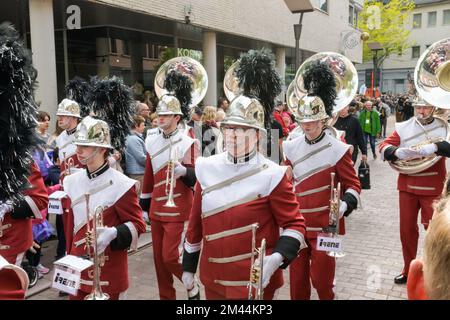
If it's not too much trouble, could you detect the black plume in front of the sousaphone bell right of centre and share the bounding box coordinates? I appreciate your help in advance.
[303,61,337,117]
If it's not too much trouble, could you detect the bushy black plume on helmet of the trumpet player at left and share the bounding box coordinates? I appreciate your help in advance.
[88,77,134,151]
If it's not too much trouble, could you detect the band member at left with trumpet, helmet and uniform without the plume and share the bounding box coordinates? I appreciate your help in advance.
[63,117,145,300]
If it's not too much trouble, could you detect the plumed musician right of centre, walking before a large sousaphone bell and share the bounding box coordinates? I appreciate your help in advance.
[283,61,361,300]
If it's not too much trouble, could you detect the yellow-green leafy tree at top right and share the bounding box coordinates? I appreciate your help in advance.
[358,0,415,68]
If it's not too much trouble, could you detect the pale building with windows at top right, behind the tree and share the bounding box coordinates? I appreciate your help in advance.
[357,0,450,94]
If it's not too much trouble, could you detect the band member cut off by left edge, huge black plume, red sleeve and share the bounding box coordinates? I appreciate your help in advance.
[0,23,48,266]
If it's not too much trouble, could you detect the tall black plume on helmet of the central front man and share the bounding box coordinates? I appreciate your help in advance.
[236,49,281,129]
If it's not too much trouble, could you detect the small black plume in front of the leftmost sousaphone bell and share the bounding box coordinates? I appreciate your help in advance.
[164,71,193,119]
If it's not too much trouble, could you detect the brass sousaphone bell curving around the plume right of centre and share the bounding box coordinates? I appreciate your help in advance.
[286,52,358,138]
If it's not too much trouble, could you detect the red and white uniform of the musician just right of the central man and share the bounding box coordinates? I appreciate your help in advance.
[283,134,361,300]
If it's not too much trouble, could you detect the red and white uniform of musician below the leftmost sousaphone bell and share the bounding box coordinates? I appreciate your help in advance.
[141,130,199,300]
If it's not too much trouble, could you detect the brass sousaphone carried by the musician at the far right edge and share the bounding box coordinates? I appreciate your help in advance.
[389,38,450,174]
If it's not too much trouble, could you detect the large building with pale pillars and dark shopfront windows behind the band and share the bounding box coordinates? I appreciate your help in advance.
[0,0,362,120]
